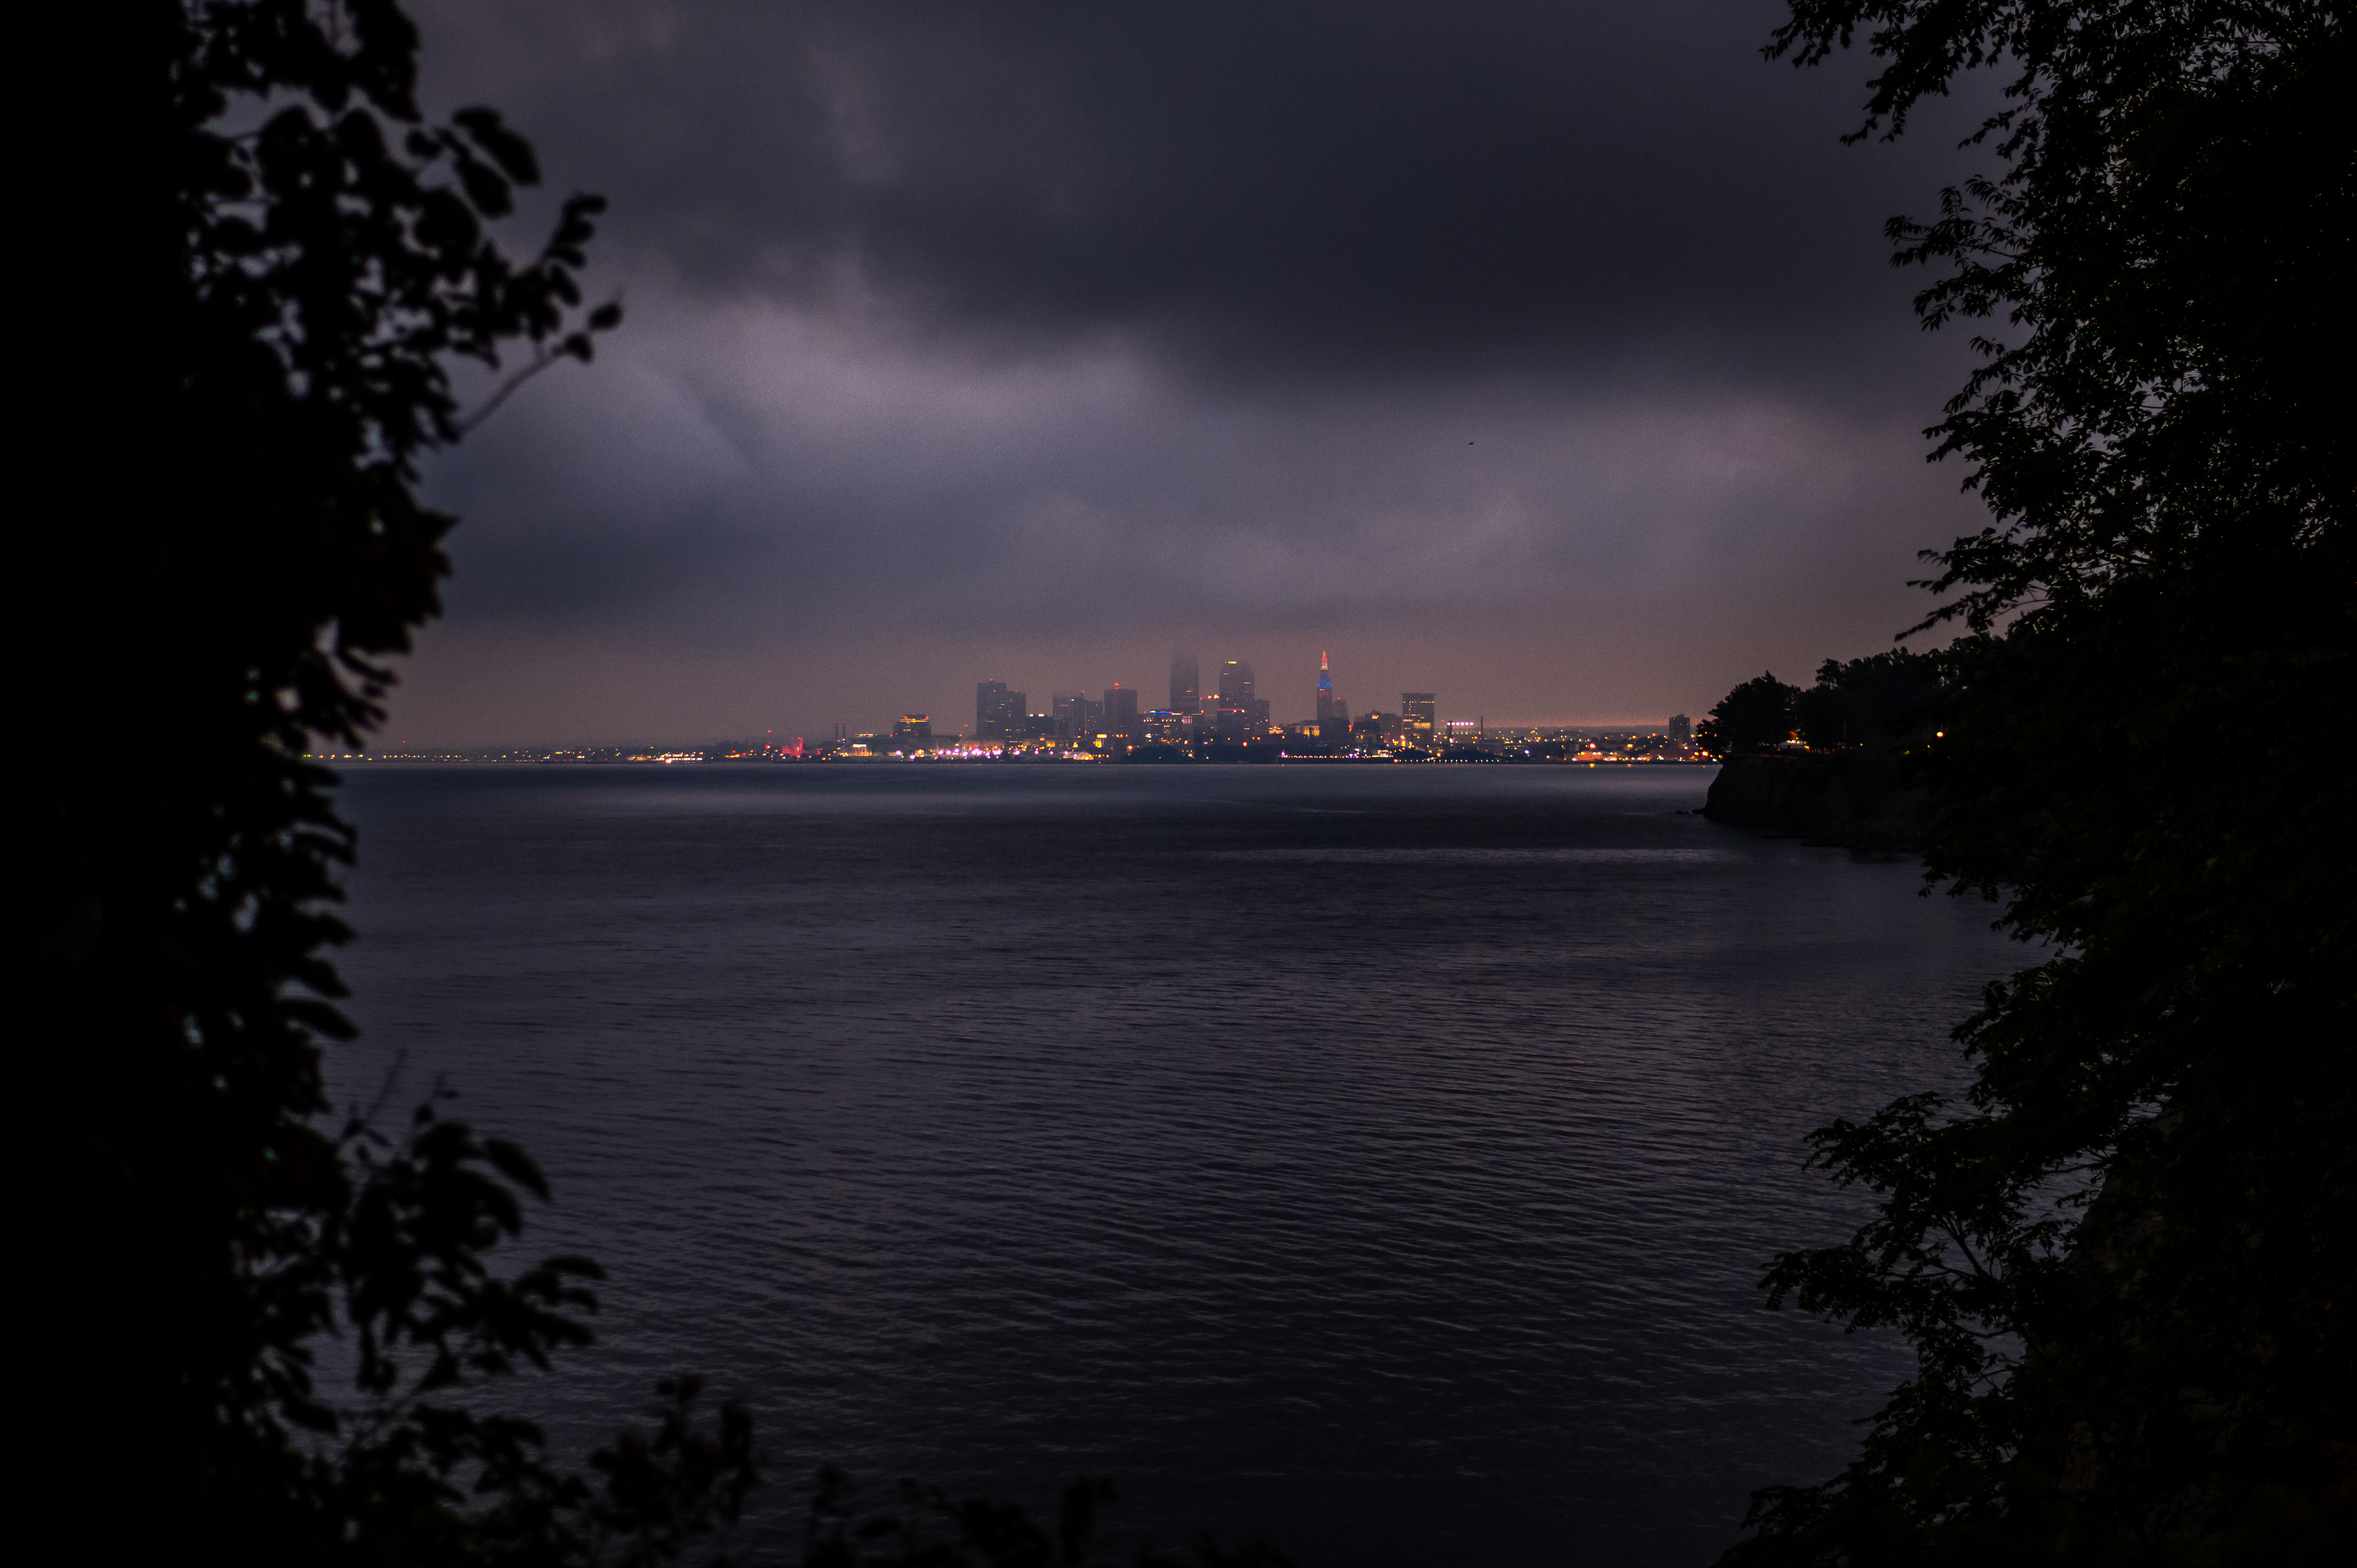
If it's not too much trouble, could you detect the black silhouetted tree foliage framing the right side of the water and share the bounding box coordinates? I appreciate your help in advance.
[1730,0,2357,1566]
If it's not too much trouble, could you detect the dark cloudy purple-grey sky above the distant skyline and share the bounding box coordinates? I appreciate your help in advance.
[389,0,1977,745]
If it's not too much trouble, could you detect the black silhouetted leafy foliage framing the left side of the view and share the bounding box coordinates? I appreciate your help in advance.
[19,0,752,1563]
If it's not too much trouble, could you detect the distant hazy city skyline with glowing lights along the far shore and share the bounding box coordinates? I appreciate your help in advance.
[313,653,1700,764]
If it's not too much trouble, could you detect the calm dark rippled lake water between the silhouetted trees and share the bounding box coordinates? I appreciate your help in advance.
[335,764,2022,1568]
